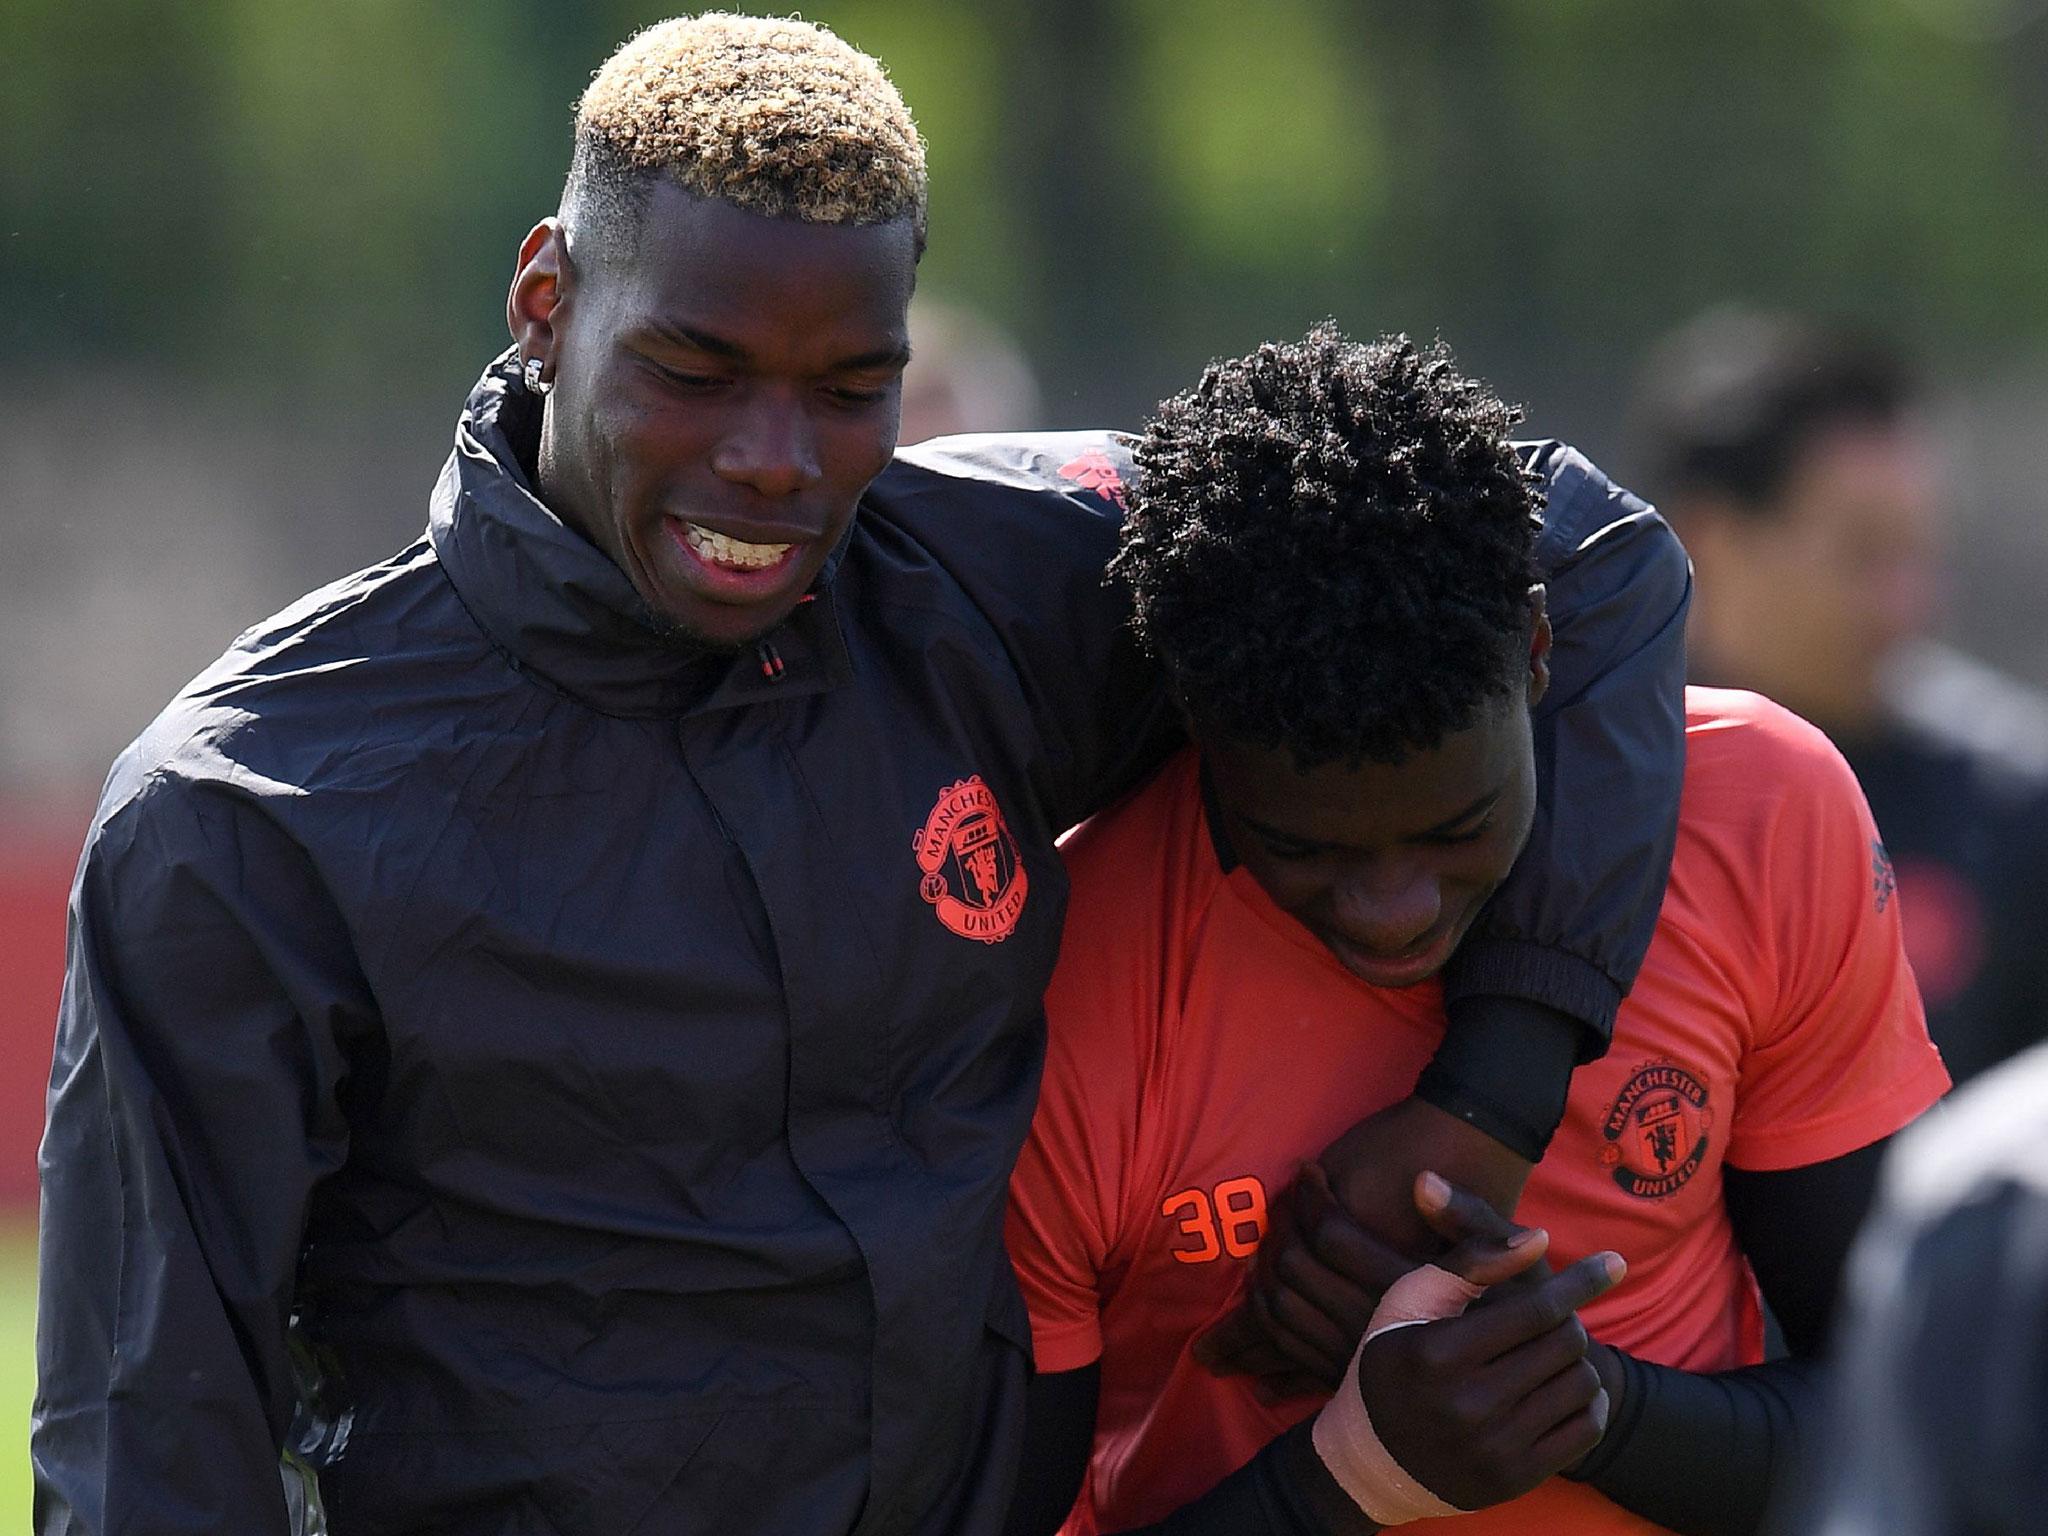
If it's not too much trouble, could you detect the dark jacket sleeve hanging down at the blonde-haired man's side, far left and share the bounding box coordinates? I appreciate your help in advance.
[31,770,365,1536]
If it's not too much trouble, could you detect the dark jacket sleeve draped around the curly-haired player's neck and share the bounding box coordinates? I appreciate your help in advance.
[1444,442,1692,1056]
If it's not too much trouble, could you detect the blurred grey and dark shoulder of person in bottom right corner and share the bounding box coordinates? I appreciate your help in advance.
[1786,1044,2048,1536]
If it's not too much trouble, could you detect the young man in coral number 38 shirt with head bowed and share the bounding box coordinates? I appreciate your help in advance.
[1010,328,1948,1536]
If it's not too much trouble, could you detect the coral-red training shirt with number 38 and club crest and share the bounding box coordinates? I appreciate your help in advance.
[1010,688,1948,1536]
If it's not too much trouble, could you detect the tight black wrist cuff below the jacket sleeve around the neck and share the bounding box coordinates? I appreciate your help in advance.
[1415,995,1585,1163]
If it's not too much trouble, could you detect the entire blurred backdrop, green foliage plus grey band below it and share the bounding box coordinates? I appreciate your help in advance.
[12,0,2048,797]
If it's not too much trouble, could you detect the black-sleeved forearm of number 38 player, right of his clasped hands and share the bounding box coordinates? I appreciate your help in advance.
[1567,1350,1823,1536]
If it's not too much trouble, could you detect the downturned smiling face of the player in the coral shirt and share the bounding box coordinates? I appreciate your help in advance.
[1196,602,1550,987]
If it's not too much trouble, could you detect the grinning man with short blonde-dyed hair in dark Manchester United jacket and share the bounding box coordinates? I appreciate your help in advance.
[33,14,1683,1536]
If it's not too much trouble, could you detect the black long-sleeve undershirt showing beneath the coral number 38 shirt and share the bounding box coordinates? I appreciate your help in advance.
[1008,1141,1886,1536]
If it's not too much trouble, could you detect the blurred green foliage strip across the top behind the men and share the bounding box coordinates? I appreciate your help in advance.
[12,0,2048,426]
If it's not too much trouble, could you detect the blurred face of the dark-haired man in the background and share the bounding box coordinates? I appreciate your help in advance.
[1675,424,1942,733]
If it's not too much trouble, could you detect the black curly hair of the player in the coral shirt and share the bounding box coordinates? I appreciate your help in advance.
[1112,322,1538,772]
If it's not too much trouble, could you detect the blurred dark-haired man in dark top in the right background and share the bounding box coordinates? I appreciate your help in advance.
[1634,307,2048,1081]
